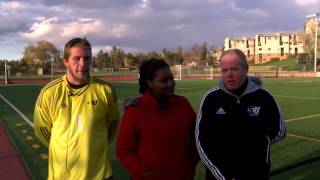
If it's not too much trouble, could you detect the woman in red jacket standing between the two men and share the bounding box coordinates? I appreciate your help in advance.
[116,59,198,180]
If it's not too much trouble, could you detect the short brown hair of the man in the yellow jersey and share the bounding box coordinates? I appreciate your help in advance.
[63,38,91,59]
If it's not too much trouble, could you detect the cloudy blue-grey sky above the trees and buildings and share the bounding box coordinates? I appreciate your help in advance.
[0,0,320,60]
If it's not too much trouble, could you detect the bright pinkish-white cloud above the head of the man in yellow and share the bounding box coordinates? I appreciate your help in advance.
[21,17,129,49]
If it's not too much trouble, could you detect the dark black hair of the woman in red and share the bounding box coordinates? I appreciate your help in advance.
[139,58,170,94]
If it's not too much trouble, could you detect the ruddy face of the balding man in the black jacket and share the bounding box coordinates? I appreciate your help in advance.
[220,54,248,91]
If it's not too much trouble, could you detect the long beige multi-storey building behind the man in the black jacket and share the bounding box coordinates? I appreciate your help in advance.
[224,32,304,64]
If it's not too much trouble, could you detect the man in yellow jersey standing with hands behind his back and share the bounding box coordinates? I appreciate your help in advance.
[34,38,119,180]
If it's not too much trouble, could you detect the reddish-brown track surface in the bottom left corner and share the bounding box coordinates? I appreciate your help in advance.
[0,123,30,180]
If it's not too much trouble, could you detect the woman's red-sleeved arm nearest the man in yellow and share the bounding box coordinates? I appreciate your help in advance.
[116,107,152,176]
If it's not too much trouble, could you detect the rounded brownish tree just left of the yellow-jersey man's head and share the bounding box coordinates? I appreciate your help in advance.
[22,40,60,73]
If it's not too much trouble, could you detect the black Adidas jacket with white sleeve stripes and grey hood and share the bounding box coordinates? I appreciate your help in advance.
[195,77,285,180]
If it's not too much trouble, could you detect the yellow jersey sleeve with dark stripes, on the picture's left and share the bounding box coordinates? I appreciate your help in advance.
[33,92,52,147]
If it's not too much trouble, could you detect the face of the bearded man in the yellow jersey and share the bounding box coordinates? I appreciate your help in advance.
[63,47,92,85]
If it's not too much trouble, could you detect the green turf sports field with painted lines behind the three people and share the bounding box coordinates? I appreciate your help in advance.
[0,78,320,180]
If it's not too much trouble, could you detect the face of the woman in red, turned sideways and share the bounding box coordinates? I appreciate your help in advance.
[147,67,175,97]
